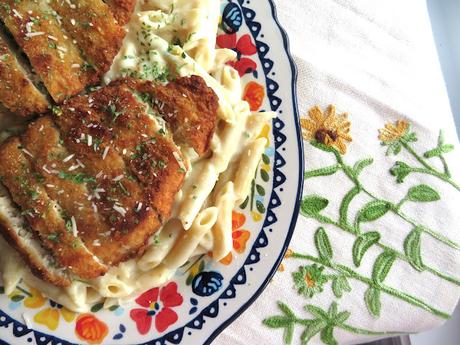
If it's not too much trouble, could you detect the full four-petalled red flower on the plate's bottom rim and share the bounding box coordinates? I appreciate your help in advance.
[130,282,183,334]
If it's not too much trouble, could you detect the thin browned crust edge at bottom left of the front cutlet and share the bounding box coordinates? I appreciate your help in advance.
[0,214,71,287]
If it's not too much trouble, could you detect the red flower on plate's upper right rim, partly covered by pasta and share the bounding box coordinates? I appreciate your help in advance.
[217,34,257,77]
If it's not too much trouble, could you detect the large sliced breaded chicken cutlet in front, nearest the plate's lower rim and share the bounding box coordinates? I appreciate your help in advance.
[0,76,218,286]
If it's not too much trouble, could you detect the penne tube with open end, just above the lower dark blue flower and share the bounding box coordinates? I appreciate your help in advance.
[163,207,218,269]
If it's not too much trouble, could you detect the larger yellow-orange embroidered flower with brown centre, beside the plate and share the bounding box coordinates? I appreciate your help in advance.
[300,105,352,154]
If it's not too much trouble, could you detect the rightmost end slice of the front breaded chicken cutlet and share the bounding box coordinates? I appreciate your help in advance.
[115,76,219,155]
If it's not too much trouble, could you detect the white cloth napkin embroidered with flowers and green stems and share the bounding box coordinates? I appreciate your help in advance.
[214,0,460,345]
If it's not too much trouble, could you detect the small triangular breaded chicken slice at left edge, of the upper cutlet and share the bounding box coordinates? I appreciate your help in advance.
[0,35,49,116]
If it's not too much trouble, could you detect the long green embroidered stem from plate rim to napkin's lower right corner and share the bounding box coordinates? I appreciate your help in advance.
[291,253,450,319]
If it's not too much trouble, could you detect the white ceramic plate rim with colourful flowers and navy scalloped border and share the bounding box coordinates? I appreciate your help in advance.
[0,0,303,345]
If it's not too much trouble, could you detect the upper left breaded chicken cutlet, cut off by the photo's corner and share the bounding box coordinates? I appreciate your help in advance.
[0,0,135,115]
